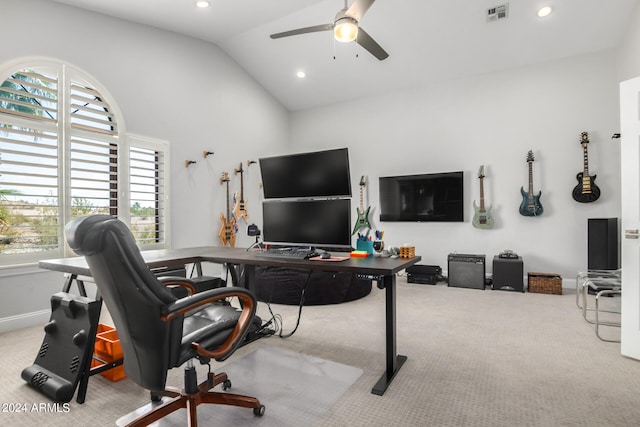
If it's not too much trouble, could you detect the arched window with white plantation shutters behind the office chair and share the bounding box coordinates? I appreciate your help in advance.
[0,61,168,265]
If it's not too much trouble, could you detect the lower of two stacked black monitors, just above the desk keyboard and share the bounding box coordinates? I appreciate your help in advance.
[262,199,351,250]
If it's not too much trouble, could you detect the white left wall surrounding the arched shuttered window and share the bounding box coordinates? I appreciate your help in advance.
[0,0,289,331]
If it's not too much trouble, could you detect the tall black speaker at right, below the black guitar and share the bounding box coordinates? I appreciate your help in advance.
[587,218,620,270]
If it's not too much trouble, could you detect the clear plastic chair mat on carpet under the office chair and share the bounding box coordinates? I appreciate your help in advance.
[117,347,363,427]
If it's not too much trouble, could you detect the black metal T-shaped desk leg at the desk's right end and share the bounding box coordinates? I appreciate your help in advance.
[371,274,407,396]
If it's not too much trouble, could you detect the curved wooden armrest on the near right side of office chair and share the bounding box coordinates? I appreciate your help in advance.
[161,286,257,360]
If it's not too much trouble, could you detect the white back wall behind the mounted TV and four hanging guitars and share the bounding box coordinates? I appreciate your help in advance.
[291,51,620,280]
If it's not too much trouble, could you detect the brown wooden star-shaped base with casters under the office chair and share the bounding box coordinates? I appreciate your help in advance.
[125,368,265,427]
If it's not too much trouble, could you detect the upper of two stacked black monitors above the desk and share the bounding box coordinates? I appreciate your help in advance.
[259,148,351,199]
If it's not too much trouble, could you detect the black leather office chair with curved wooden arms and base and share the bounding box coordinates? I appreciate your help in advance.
[65,215,264,426]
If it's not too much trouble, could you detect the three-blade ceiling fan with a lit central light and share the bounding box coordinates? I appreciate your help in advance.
[270,0,389,61]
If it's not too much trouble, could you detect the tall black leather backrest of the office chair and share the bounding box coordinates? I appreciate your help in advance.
[65,215,183,391]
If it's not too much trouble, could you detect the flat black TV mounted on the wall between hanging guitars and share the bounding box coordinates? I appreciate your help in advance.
[379,171,464,222]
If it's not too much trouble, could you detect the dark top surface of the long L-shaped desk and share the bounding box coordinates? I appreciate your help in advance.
[38,246,421,276]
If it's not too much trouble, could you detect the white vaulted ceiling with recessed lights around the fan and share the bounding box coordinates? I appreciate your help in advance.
[50,0,640,111]
